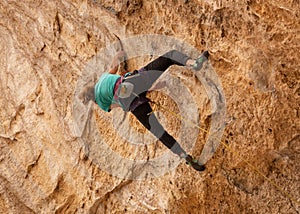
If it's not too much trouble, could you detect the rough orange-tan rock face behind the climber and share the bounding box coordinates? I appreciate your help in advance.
[0,0,300,213]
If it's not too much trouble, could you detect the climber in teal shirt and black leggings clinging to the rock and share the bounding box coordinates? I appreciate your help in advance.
[83,50,209,171]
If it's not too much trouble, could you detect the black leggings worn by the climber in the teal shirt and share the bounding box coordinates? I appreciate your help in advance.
[132,50,191,155]
